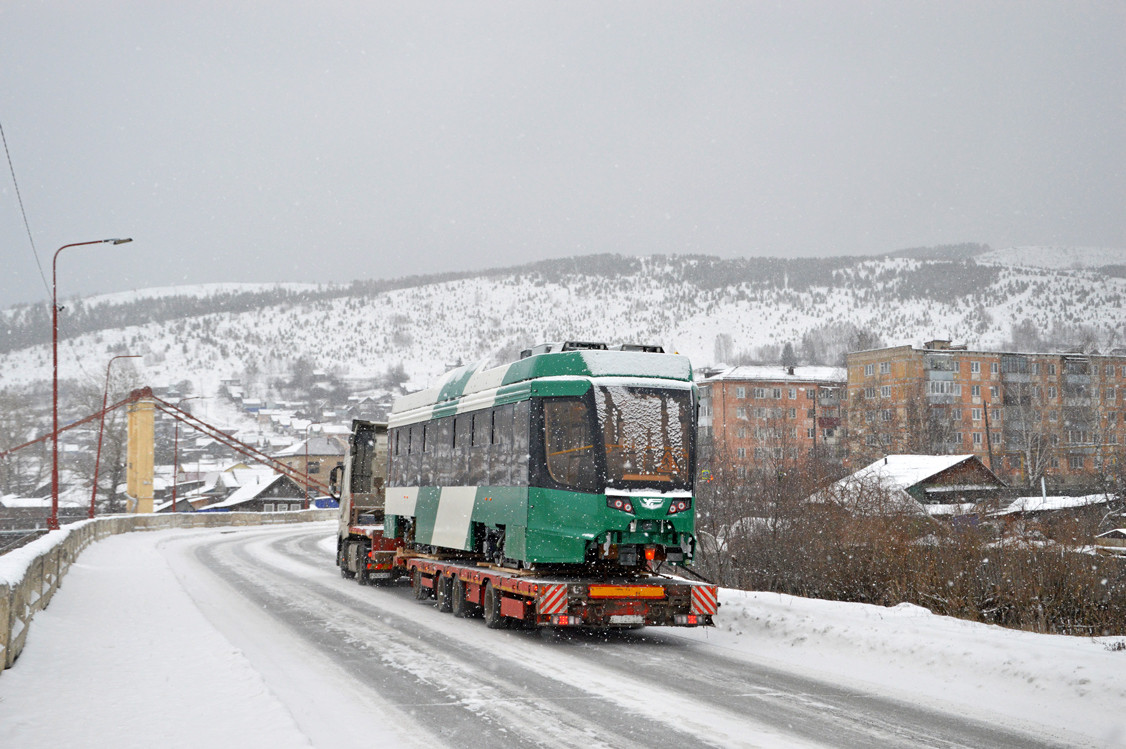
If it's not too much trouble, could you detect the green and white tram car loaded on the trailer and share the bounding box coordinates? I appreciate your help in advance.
[384,341,698,572]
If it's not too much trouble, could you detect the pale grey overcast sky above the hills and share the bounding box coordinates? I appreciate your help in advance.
[0,0,1126,306]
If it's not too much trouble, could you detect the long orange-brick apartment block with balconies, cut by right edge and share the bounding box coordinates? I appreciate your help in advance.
[847,340,1126,484]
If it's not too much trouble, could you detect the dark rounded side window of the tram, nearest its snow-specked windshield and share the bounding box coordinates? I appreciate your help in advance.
[544,398,598,491]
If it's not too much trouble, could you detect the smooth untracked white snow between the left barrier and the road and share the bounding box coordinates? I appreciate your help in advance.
[0,530,311,749]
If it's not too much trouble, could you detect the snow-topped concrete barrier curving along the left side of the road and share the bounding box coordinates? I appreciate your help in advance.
[0,509,338,674]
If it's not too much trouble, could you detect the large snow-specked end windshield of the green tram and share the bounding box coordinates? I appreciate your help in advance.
[595,386,692,491]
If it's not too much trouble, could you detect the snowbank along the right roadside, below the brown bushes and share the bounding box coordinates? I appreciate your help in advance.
[677,589,1126,747]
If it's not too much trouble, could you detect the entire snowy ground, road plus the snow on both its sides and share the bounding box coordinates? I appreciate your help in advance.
[0,523,1126,749]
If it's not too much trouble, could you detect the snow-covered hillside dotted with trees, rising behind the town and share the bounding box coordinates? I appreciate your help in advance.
[0,248,1126,394]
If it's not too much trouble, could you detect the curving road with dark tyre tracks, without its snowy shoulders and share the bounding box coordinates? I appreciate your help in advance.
[164,526,1080,748]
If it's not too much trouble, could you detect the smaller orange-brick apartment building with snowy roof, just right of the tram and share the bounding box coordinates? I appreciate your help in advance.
[698,366,847,478]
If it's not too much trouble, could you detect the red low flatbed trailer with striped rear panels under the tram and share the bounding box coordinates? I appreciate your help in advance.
[393,549,720,628]
